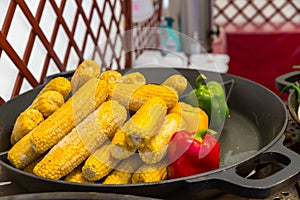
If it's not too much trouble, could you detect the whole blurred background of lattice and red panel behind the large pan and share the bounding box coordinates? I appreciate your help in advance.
[0,0,300,103]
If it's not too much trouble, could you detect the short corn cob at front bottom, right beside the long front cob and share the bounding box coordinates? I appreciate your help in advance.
[82,143,120,181]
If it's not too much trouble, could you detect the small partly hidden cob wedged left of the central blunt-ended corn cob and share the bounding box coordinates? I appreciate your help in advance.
[110,129,136,160]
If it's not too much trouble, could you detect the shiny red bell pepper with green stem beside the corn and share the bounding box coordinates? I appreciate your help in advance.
[168,129,220,178]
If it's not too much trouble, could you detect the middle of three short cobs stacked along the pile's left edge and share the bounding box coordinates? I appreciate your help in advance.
[30,90,65,118]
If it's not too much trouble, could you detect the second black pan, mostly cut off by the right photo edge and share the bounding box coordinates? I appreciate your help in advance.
[276,71,300,126]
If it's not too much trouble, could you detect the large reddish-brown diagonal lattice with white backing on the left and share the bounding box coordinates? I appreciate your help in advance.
[0,0,161,105]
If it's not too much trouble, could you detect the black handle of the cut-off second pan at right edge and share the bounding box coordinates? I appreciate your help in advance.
[275,71,300,92]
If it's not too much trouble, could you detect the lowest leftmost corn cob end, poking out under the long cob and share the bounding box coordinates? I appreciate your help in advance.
[7,132,42,169]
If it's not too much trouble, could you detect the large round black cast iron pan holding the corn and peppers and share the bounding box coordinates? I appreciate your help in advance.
[0,68,300,199]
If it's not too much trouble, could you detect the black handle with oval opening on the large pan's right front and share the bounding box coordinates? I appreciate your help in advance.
[186,136,300,198]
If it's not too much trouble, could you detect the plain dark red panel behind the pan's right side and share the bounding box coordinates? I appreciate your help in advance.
[226,26,300,97]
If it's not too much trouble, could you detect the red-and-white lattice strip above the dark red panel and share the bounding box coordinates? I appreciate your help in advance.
[214,0,300,30]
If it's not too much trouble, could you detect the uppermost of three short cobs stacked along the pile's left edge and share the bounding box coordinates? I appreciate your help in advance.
[39,77,71,99]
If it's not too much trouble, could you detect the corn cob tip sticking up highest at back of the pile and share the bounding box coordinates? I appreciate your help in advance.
[71,60,100,94]
